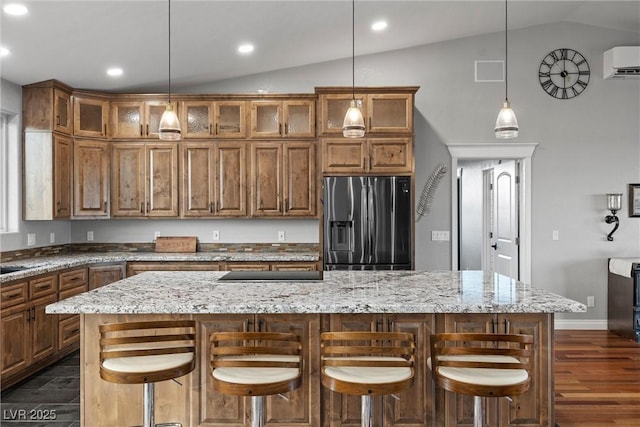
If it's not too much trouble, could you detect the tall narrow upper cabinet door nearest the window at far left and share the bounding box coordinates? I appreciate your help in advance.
[53,135,72,218]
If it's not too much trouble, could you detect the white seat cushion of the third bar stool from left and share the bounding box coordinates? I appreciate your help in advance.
[324,356,411,384]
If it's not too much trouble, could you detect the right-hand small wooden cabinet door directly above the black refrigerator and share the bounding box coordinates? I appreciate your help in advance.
[368,138,413,173]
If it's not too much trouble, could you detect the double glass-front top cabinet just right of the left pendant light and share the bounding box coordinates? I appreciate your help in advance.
[180,100,247,138]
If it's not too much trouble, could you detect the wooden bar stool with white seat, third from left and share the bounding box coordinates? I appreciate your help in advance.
[320,332,415,427]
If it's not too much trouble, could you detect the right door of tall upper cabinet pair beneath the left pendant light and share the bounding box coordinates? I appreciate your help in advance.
[146,143,178,216]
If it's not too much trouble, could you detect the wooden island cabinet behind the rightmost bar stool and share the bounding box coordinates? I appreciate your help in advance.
[437,314,553,427]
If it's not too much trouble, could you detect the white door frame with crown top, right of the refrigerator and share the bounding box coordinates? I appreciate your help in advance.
[446,142,538,283]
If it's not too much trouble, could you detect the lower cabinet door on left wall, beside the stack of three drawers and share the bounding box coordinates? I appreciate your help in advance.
[30,294,58,363]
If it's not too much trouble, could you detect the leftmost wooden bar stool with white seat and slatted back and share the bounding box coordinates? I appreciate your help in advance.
[99,320,196,427]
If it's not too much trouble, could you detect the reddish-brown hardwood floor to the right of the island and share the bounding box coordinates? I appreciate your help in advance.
[555,331,640,427]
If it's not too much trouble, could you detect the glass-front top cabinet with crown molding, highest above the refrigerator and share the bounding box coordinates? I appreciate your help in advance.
[316,87,418,135]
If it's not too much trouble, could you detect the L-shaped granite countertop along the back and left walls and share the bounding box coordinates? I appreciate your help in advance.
[0,251,318,284]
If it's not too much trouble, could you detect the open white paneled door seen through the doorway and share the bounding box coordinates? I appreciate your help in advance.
[485,160,520,279]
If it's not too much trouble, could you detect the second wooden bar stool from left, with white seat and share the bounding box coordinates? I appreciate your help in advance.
[210,332,302,427]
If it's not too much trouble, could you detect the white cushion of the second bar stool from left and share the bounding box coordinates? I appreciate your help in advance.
[212,354,300,384]
